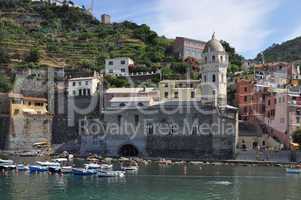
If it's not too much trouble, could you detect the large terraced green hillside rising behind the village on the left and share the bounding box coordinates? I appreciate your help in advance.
[0,0,174,68]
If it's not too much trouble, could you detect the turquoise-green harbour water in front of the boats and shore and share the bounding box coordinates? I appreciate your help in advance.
[0,165,301,200]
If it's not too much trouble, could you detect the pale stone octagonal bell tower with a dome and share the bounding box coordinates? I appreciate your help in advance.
[200,34,229,106]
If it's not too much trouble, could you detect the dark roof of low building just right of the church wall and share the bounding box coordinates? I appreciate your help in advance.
[239,121,263,137]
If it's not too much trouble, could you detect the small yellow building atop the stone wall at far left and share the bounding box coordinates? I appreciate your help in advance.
[9,93,48,116]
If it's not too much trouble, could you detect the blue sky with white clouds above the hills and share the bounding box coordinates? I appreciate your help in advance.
[73,0,301,58]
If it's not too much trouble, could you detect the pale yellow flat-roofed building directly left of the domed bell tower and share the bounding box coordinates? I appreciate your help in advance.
[159,80,201,101]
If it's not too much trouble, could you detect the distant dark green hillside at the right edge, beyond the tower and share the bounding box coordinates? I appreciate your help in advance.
[256,37,301,62]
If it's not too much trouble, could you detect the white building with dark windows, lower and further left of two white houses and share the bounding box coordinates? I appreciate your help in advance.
[68,77,100,96]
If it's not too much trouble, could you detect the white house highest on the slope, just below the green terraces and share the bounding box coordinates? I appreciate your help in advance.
[105,57,134,76]
